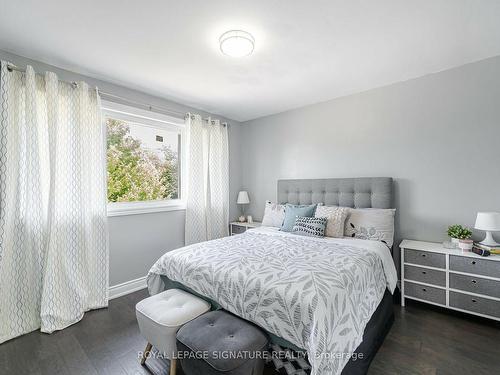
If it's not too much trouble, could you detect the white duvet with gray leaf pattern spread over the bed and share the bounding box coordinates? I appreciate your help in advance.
[147,228,397,375]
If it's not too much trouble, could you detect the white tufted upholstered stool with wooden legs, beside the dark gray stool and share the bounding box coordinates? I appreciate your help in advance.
[135,289,210,375]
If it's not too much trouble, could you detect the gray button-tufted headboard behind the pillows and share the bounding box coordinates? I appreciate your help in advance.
[278,177,393,208]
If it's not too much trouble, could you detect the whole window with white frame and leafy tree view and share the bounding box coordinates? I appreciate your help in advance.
[103,103,184,216]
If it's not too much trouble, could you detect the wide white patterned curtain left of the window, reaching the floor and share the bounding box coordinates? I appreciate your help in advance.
[0,61,108,342]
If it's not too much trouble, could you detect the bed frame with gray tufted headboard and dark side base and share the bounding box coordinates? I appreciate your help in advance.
[278,177,394,375]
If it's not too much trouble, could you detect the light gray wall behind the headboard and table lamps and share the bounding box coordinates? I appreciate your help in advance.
[241,57,500,260]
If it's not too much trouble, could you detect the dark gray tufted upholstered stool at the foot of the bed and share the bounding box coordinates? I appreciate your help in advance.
[177,311,268,375]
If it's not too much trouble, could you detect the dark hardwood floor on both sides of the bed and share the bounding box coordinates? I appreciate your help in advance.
[0,290,500,375]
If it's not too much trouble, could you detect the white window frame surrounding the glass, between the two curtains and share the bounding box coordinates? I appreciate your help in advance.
[101,100,187,216]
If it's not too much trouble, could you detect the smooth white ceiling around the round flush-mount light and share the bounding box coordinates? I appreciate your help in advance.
[0,0,500,121]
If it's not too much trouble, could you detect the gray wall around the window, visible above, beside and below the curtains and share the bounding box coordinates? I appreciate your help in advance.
[0,50,241,285]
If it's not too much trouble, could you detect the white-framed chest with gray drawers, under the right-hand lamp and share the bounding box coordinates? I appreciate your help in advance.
[399,240,500,320]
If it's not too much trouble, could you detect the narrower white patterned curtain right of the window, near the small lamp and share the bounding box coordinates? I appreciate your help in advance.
[185,115,229,245]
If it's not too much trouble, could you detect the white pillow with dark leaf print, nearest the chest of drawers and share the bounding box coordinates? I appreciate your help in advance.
[344,208,396,247]
